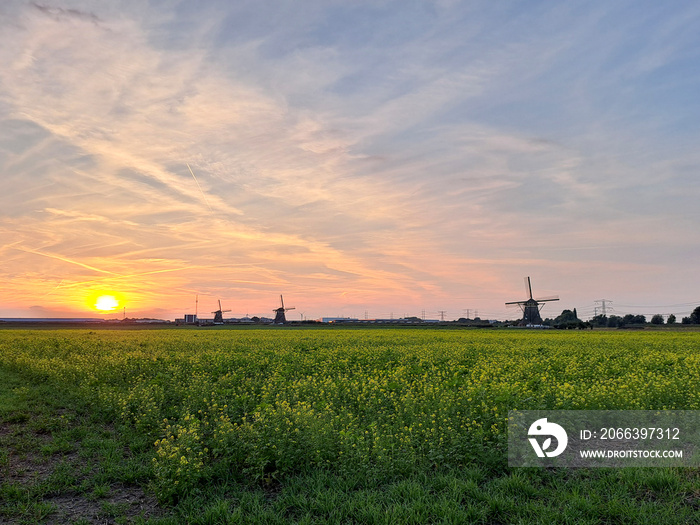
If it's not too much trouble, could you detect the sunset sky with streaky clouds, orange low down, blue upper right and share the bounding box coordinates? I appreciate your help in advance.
[0,0,700,320]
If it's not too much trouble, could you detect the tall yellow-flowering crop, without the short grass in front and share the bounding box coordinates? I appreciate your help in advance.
[0,329,700,522]
